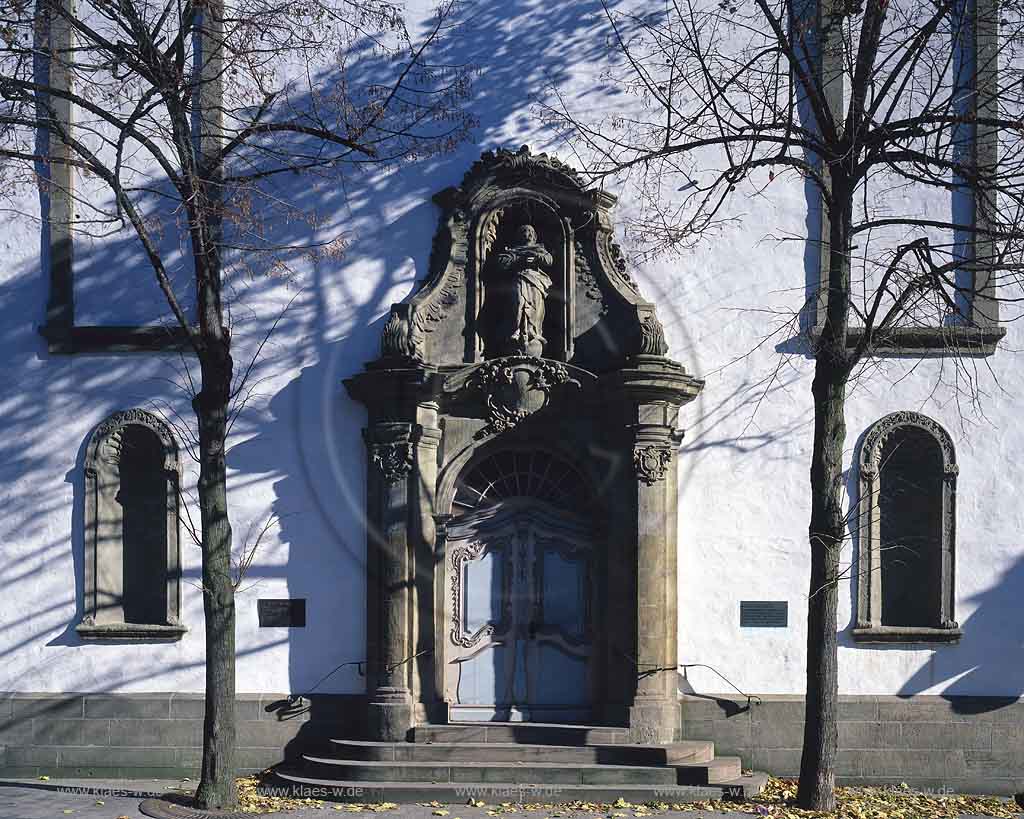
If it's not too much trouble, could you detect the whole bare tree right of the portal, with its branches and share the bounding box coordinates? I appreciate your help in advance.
[545,0,1024,810]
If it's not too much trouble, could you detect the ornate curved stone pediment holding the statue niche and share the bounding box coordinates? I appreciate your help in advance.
[381,145,668,372]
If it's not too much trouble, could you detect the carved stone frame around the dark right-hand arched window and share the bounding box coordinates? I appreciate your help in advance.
[853,411,963,643]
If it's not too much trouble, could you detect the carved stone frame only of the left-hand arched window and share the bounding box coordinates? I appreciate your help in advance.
[76,407,188,641]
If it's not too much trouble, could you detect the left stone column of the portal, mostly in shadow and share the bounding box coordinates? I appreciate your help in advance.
[366,422,414,741]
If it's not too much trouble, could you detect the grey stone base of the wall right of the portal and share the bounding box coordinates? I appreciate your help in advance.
[681,695,1024,794]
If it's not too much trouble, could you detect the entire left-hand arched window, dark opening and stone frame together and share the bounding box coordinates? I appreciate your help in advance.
[77,410,186,640]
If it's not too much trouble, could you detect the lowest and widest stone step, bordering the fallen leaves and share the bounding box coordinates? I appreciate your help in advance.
[268,769,753,805]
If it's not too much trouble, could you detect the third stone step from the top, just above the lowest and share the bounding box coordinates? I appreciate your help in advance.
[302,755,679,787]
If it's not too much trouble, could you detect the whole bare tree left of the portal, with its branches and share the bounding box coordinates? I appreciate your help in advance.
[0,0,472,808]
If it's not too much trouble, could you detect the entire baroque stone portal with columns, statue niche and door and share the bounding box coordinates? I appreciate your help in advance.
[345,147,702,742]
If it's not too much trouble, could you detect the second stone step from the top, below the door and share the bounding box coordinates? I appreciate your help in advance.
[324,739,715,766]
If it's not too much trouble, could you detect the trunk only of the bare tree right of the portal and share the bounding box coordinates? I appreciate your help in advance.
[797,171,853,811]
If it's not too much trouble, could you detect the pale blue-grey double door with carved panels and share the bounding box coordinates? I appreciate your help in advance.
[445,502,592,721]
